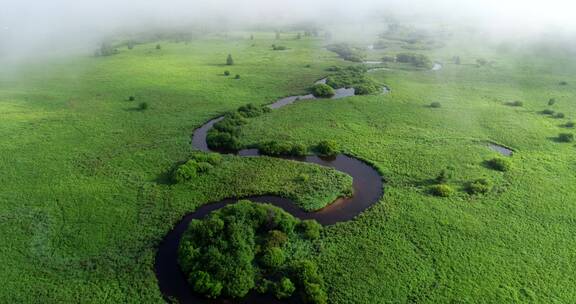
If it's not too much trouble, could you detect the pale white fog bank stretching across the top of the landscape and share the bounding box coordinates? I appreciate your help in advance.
[0,0,576,63]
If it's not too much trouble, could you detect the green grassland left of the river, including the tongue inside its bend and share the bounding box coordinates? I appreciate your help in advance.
[0,34,350,303]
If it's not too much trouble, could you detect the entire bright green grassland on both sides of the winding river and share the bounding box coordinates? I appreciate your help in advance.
[0,26,576,303]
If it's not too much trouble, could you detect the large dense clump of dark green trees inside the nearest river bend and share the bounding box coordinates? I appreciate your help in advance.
[178,201,326,303]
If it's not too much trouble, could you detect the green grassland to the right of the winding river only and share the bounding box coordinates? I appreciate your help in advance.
[237,34,576,303]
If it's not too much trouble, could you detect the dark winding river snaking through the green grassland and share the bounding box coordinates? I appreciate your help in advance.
[154,78,383,303]
